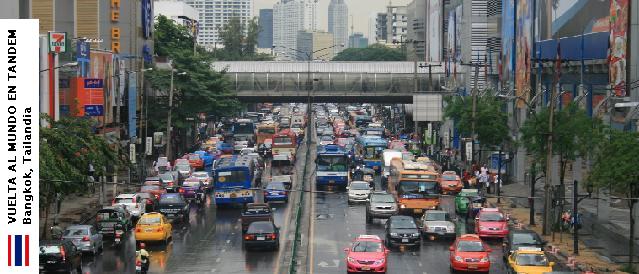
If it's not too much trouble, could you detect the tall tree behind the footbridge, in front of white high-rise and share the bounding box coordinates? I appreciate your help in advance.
[213,17,273,61]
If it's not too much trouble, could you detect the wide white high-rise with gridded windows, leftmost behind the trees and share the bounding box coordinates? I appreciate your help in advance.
[185,0,253,49]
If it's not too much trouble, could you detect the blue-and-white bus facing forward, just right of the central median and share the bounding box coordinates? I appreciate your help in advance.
[315,145,350,187]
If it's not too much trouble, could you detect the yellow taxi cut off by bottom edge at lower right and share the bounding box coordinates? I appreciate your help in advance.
[508,247,555,274]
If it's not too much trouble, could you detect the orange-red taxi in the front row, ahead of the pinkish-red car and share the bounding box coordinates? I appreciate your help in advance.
[449,234,492,273]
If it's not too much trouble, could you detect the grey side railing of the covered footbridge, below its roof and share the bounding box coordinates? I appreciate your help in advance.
[227,73,456,93]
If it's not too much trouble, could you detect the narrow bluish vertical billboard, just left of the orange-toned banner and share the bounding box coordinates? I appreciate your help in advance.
[499,0,515,83]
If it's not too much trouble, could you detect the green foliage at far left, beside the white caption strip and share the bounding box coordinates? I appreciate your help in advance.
[39,115,123,207]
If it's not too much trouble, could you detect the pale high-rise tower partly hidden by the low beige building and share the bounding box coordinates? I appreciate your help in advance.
[273,0,318,60]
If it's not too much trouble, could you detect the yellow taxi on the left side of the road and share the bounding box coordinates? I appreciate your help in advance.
[135,212,173,243]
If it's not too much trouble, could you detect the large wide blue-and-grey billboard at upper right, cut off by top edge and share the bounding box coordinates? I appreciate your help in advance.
[539,0,608,40]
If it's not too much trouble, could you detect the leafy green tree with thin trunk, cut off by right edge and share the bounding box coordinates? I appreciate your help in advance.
[588,130,639,266]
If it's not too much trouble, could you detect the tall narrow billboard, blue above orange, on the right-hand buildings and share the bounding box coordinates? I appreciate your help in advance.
[515,0,534,108]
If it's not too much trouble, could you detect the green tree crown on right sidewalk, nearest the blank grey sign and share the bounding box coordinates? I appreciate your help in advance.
[444,96,510,148]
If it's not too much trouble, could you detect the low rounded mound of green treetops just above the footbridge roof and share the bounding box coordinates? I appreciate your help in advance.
[333,44,406,61]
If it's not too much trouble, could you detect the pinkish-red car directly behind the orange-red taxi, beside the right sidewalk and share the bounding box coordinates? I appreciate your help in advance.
[475,208,508,238]
